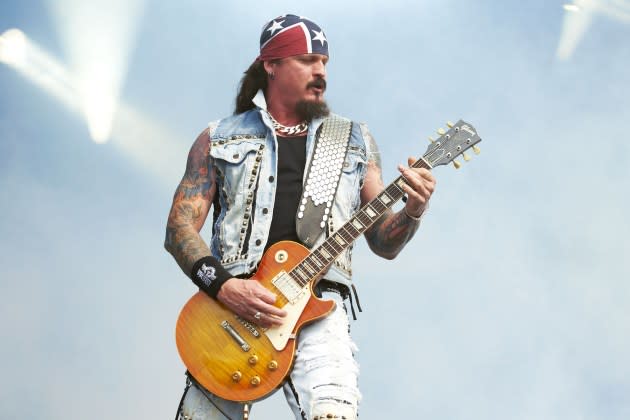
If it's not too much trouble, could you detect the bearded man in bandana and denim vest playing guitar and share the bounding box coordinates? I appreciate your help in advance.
[165,15,435,420]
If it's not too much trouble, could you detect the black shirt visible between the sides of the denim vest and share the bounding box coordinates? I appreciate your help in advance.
[265,136,306,250]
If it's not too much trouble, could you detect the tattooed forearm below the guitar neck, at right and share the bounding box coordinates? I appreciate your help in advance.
[365,209,420,260]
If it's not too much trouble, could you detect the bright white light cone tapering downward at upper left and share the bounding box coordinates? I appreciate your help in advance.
[46,0,146,143]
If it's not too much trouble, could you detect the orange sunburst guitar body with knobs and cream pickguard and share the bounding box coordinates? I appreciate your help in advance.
[175,241,335,402]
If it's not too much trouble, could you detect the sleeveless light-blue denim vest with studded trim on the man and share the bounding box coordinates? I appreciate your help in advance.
[209,91,370,285]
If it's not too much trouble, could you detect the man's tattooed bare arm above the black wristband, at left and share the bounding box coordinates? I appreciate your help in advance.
[164,130,216,275]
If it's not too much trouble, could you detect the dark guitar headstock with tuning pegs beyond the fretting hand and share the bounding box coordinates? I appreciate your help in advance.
[422,120,481,169]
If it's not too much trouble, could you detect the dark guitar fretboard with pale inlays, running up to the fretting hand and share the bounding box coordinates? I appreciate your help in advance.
[289,158,431,286]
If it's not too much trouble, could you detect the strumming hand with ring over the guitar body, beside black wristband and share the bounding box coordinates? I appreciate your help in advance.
[217,277,287,328]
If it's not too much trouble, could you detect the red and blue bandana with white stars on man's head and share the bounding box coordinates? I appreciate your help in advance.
[256,15,328,61]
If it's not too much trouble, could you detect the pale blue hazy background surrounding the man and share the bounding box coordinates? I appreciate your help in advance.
[0,0,630,420]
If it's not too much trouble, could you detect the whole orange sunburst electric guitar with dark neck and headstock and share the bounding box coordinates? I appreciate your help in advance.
[176,120,481,402]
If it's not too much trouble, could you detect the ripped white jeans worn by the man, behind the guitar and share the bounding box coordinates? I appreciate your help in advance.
[179,291,361,420]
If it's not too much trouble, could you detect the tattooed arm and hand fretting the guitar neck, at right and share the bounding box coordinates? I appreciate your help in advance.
[361,133,435,259]
